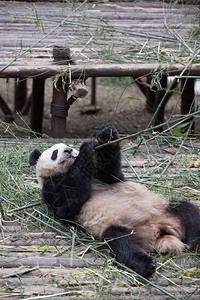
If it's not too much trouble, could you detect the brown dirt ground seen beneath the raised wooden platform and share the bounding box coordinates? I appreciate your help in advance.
[0,78,200,138]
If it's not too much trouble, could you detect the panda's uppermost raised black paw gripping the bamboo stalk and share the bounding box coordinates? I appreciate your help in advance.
[97,125,119,144]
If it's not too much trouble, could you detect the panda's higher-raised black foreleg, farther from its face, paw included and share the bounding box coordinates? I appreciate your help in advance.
[96,125,124,184]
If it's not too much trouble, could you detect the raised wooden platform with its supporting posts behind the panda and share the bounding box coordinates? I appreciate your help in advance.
[0,0,200,137]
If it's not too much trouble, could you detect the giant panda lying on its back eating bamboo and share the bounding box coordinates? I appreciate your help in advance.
[29,125,200,278]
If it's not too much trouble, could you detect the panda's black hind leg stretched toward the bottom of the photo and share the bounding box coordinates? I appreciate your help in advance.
[102,226,156,278]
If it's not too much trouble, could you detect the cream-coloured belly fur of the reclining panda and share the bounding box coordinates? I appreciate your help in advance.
[76,182,183,252]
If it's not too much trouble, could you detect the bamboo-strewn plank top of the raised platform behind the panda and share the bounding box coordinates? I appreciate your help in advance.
[0,1,198,68]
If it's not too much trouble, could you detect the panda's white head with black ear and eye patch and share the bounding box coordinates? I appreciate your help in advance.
[29,143,79,186]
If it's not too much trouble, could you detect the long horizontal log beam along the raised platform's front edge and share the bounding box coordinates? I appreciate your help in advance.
[0,63,200,79]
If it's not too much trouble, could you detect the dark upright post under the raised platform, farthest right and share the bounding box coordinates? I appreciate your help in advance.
[181,78,195,131]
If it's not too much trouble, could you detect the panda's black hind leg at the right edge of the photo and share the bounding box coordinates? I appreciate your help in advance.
[168,200,200,251]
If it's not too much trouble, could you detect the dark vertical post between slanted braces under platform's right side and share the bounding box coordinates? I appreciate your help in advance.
[155,76,168,127]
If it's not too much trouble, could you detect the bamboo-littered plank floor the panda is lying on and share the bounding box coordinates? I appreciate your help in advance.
[0,140,200,300]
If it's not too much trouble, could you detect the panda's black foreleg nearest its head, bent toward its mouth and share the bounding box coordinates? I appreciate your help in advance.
[42,142,98,220]
